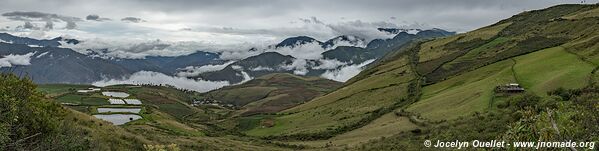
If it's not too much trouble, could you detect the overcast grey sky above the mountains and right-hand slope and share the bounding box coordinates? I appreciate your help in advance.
[0,0,599,57]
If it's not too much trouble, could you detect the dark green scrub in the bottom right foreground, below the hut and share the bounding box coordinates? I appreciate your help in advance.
[359,86,599,150]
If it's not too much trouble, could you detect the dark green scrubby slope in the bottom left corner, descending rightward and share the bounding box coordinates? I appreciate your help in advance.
[0,74,143,150]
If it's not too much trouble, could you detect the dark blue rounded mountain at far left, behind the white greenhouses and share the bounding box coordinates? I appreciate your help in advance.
[0,43,132,83]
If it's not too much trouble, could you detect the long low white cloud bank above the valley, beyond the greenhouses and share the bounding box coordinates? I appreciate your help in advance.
[92,71,230,92]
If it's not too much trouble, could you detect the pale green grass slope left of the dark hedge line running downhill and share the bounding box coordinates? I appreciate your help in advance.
[246,55,415,136]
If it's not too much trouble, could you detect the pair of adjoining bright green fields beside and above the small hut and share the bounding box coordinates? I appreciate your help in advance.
[408,47,594,121]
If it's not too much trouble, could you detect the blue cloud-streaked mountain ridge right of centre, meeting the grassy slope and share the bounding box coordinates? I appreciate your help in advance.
[197,29,455,83]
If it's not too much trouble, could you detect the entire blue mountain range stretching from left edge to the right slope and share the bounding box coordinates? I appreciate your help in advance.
[0,29,454,83]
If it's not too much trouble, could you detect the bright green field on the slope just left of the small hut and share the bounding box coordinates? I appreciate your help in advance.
[407,60,514,121]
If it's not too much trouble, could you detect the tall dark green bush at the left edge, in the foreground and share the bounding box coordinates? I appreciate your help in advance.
[0,73,85,150]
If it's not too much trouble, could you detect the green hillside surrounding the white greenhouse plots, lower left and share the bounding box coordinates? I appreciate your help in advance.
[38,84,290,150]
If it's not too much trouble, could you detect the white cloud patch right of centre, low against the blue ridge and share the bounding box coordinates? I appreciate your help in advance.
[321,59,374,82]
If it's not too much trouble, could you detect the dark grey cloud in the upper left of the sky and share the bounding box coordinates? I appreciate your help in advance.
[2,11,82,29]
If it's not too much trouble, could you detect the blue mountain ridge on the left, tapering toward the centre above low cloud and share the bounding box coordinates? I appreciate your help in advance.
[0,33,222,84]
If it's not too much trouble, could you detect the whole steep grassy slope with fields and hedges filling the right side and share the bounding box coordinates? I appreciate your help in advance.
[238,5,599,149]
